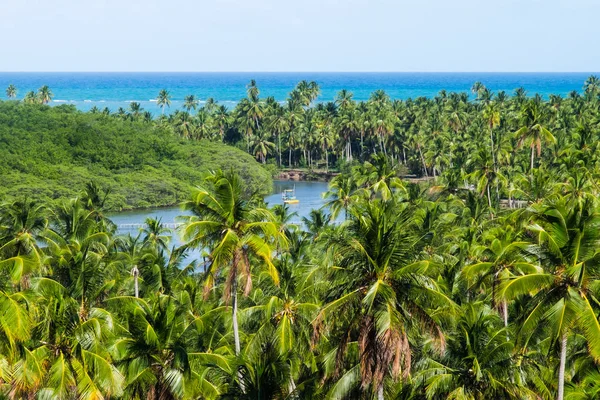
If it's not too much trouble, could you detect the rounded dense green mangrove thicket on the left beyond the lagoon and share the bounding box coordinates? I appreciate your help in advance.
[0,101,271,210]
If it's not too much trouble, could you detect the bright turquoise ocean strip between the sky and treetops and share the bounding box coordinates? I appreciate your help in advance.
[0,72,594,113]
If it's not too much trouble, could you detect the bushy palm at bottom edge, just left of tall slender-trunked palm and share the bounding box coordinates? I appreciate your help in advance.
[109,293,231,400]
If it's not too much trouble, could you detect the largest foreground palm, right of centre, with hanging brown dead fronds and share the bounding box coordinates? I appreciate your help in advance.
[315,200,452,399]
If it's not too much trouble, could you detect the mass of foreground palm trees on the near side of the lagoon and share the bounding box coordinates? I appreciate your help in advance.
[0,155,600,400]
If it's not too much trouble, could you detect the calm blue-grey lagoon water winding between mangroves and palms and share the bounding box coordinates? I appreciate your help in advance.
[108,181,327,261]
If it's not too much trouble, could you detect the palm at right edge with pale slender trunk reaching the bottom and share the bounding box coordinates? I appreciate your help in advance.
[498,199,600,400]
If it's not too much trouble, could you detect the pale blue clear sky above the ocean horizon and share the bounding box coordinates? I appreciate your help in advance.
[0,0,600,71]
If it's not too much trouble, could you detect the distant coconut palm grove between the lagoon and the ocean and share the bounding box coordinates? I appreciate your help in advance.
[71,76,600,191]
